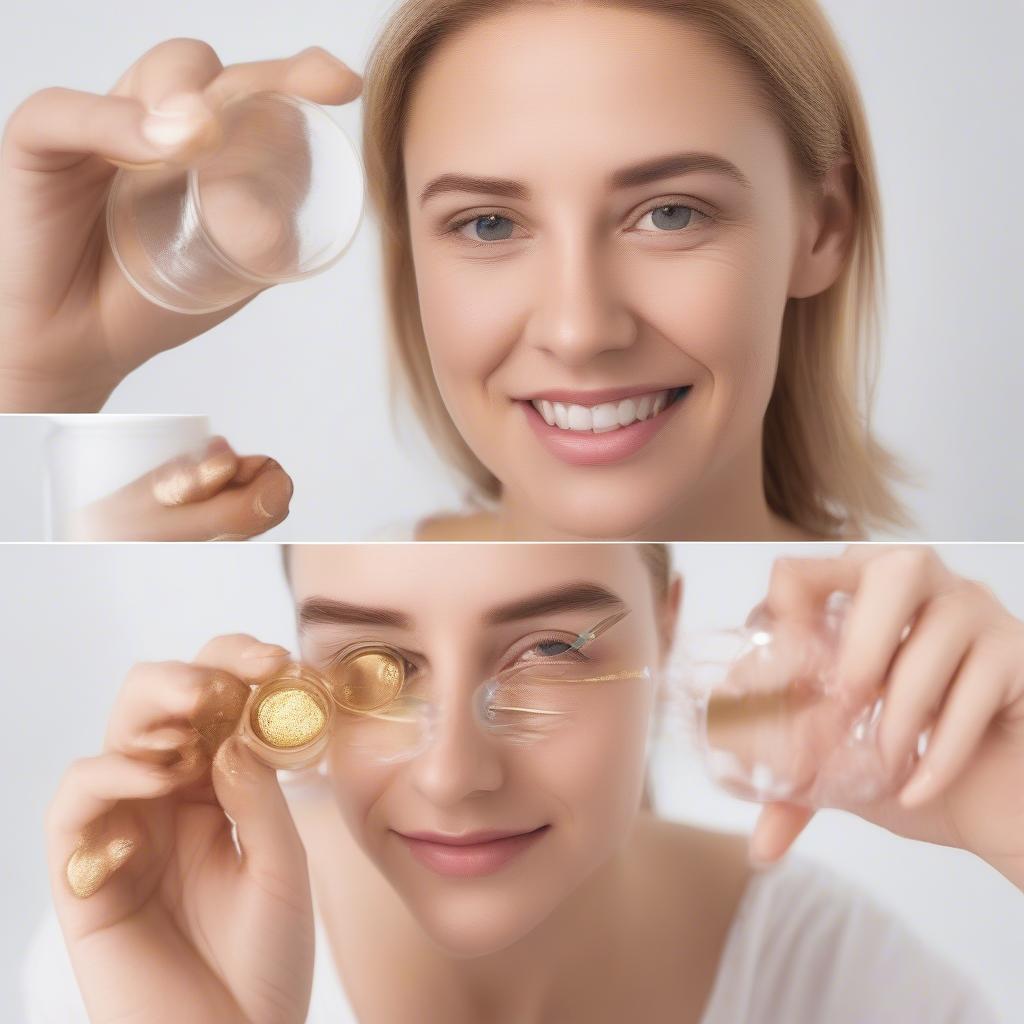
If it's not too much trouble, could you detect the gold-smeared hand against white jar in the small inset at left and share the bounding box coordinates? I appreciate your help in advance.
[70,437,293,541]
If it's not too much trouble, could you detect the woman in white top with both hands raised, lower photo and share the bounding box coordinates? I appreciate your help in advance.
[28,545,1024,1024]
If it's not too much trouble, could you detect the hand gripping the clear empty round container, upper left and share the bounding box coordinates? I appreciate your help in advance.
[0,39,362,413]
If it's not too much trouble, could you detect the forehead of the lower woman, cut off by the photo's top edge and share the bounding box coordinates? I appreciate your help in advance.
[290,543,652,621]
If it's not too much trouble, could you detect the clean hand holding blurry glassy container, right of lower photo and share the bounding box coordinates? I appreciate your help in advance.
[750,545,1024,890]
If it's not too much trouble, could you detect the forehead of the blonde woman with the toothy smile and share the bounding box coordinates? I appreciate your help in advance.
[404,5,783,195]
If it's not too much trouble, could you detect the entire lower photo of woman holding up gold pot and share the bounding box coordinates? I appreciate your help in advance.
[8,543,1024,1024]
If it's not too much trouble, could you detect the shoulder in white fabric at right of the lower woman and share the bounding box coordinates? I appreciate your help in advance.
[703,852,995,1024]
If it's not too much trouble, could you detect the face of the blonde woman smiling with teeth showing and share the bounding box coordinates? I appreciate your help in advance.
[403,5,801,537]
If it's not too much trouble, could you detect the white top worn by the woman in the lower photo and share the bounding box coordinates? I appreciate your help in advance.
[23,852,997,1024]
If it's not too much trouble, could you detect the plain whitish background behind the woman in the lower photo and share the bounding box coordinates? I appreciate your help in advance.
[0,544,1024,1021]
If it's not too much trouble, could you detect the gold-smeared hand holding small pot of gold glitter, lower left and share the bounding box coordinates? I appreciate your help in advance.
[46,635,313,1024]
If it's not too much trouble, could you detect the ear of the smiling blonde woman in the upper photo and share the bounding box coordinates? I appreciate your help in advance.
[790,155,857,299]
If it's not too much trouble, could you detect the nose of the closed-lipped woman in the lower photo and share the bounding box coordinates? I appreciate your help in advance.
[412,690,504,807]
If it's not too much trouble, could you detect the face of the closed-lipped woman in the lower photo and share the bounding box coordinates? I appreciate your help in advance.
[292,545,667,956]
